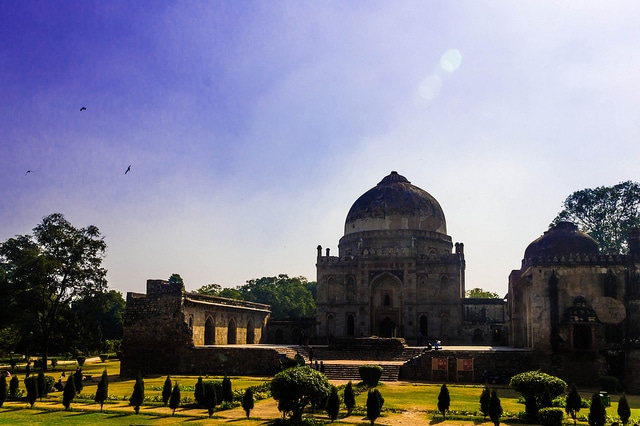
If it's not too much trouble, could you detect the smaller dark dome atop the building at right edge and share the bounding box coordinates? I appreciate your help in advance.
[524,222,598,259]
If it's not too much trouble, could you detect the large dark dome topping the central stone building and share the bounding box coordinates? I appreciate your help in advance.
[344,172,447,235]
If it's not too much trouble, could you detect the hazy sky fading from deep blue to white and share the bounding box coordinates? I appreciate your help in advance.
[0,0,640,295]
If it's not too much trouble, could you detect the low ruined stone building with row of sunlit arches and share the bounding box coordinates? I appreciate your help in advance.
[120,280,278,377]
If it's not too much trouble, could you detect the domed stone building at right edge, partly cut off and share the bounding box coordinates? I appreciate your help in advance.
[508,222,640,392]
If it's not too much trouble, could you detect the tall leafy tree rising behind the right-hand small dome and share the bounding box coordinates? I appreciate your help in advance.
[553,181,640,253]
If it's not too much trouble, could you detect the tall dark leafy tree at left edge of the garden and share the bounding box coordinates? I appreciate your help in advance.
[0,213,107,370]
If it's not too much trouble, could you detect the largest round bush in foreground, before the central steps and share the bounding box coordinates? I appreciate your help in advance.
[271,365,331,423]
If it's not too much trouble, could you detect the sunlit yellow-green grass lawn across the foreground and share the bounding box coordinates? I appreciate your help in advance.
[0,360,640,426]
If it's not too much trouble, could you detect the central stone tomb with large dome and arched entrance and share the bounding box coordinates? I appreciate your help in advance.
[316,172,467,344]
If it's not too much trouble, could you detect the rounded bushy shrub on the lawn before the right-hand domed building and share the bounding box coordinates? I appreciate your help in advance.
[509,370,567,418]
